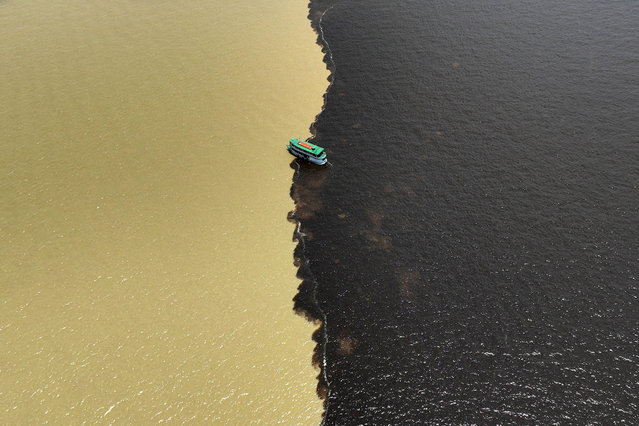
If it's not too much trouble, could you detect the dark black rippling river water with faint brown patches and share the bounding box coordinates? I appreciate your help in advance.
[292,0,639,425]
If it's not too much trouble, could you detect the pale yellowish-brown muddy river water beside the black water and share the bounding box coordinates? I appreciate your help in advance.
[0,0,328,424]
